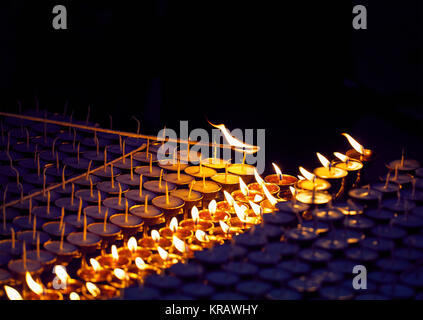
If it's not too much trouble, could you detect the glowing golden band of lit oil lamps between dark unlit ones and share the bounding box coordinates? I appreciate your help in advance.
[0,131,370,300]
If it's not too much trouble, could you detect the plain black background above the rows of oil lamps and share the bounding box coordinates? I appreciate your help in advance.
[0,0,423,178]
